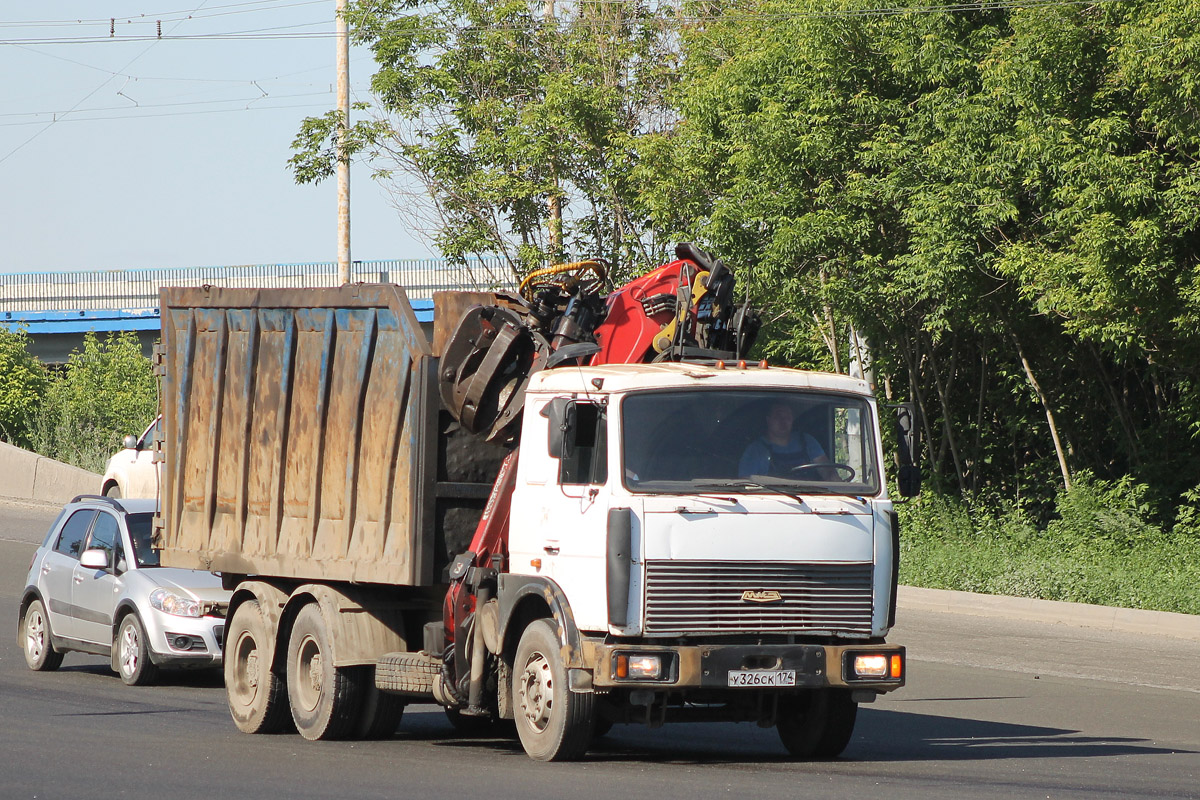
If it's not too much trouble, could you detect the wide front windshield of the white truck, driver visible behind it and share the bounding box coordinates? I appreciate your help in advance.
[620,390,880,495]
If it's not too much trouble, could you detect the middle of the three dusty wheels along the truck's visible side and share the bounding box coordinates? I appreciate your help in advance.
[287,603,362,740]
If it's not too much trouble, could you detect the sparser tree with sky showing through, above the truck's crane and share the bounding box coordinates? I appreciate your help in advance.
[290,0,676,277]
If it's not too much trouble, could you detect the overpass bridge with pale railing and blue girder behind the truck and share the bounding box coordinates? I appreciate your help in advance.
[0,258,514,363]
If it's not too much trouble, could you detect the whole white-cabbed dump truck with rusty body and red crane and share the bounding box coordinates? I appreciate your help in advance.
[156,245,919,760]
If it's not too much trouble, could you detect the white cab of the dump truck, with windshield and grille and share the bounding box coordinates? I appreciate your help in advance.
[508,363,904,714]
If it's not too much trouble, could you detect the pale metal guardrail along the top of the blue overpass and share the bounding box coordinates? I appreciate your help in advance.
[0,258,515,311]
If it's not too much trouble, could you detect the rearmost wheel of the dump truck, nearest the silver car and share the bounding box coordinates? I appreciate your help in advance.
[224,600,288,733]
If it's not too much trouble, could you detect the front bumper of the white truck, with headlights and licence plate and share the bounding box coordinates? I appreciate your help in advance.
[583,640,907,693]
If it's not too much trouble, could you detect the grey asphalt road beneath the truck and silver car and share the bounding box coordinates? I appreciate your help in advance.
[0,501,1200,800]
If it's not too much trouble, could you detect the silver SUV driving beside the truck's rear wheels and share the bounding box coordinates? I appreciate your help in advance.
[18,495,230,686]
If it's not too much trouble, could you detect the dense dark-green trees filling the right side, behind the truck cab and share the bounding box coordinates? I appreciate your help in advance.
[640,0,1200,520]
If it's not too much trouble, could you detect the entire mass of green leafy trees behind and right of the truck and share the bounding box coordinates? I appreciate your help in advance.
[304,0,1200,522]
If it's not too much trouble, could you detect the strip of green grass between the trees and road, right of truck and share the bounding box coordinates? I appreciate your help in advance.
[899,475,1200,614]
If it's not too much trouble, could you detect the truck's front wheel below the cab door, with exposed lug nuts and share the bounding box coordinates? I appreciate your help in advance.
[512,619,595,762]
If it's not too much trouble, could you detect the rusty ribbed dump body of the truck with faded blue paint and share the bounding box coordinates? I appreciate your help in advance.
[157,284,503,587]
